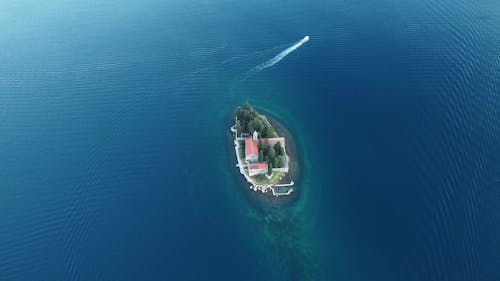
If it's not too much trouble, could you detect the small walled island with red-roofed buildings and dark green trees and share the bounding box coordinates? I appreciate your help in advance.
[231,102,294,196]
